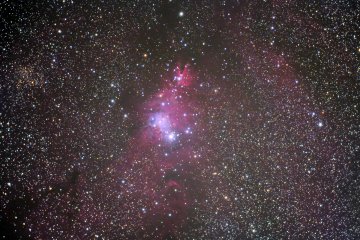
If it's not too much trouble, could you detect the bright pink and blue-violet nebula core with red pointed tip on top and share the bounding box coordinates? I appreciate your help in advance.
[144,65,199,144]
